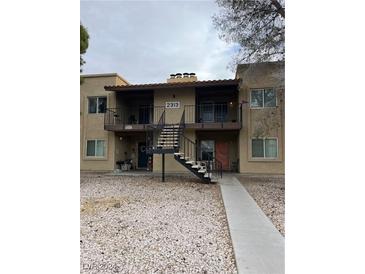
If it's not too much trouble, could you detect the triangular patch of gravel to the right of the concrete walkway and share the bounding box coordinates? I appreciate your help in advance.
[237,176,285,237]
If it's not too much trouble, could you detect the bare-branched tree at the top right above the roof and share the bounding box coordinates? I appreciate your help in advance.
[213,0,285,63]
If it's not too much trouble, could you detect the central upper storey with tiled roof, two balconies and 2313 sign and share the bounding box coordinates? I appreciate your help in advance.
[102,73,242,131]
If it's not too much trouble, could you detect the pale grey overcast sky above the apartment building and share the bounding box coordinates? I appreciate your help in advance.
[81,1,235,84]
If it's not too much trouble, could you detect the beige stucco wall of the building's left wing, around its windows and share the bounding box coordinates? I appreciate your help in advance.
[80,75,125,171]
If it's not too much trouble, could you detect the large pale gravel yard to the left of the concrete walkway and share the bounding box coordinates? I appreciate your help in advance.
[80,174,237,273]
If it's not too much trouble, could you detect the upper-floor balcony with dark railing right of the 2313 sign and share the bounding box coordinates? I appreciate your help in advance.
[183,102,242,130]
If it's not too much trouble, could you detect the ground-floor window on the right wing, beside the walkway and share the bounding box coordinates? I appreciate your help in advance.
[252,138,278,158]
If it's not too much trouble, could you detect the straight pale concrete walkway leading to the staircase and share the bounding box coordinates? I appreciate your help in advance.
[219,174,285,274]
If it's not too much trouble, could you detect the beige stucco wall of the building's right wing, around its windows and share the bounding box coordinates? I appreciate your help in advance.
[236,63,285,174]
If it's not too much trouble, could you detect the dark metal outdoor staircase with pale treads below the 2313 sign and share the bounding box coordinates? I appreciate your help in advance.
[146,108,222,183]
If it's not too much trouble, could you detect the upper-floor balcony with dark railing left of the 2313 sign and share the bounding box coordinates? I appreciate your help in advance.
[104,105,164,131]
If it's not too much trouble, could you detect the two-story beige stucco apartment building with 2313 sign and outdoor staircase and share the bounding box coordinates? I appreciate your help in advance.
[80,62,284,180]
